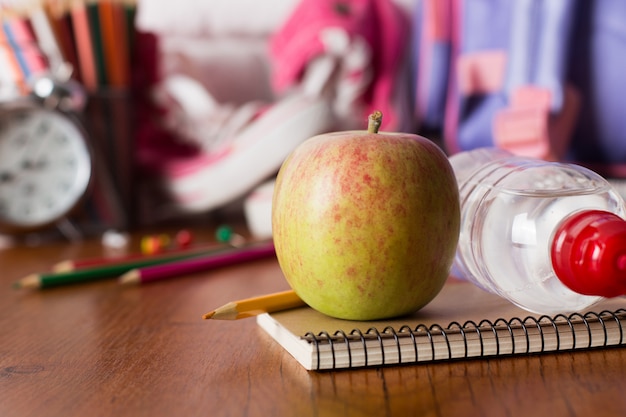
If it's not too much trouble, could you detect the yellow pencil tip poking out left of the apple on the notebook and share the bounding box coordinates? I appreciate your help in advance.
[202,290,306,320]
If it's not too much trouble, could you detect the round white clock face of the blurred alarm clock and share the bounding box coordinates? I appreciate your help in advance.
[0,108,91,229]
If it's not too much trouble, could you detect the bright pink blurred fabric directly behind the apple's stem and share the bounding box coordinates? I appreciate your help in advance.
[270,0,410,130]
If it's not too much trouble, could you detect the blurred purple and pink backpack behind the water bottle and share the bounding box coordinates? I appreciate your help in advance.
[412,0,626,177]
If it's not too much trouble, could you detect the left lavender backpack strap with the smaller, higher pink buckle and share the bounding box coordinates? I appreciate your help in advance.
[443,0,512,153]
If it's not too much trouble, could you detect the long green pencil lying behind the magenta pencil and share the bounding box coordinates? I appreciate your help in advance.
[13,245,232,289]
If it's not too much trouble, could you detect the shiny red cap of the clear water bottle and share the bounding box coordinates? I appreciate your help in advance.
[551,210,626,297]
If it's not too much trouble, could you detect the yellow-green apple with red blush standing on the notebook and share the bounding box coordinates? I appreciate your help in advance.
[272,112,460,320]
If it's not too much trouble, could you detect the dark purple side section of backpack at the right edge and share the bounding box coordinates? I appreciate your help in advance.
[567,0,626,178]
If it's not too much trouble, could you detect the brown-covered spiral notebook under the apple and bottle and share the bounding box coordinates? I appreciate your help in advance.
[257,278,626,370]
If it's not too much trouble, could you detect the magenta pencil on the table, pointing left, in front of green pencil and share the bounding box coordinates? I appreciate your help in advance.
[120,241,276,284]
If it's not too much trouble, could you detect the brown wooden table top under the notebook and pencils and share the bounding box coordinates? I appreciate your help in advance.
[0,229,626,417]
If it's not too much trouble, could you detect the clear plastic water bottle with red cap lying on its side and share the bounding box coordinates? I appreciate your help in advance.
[450,148,626,314]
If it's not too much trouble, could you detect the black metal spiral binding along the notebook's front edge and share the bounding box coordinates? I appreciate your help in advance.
[304,309,626,370]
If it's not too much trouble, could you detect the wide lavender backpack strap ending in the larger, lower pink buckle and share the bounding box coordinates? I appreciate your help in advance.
[493,0,580,160]
